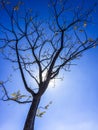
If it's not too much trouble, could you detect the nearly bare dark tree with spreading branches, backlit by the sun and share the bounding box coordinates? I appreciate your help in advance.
[0,0,98,130]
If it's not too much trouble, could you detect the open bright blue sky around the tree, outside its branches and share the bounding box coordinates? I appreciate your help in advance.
[0,0,98,130]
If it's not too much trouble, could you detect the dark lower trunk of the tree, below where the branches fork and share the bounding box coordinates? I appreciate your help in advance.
[23,98,40,130]
